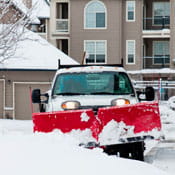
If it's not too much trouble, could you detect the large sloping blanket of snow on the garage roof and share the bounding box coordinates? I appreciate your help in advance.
[0,30,79,70]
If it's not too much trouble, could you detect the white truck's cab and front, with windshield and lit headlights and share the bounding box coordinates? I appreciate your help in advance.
[32,65,154,112]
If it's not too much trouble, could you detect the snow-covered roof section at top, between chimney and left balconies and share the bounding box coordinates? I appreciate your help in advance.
[32,0,50,18]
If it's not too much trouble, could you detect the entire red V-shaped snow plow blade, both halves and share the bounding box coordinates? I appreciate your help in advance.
[32,102,161,140]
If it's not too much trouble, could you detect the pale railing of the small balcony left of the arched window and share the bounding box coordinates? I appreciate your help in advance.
[56,19,69,33]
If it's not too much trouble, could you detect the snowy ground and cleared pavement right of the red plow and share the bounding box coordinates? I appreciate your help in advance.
[151,102,175,175]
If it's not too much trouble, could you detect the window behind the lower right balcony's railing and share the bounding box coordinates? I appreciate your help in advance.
[153,41,170,65]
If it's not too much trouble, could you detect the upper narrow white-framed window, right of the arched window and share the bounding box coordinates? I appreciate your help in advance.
[126,1,135,21]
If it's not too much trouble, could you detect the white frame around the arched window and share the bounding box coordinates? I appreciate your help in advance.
[84,0,107,30]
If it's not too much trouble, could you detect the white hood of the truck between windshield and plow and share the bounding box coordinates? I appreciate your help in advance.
[46,95,138,112]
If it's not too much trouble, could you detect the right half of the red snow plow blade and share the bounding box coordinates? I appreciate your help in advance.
[98,102,161,134]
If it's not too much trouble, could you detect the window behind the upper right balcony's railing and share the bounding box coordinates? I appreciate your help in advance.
[153,2,170,25]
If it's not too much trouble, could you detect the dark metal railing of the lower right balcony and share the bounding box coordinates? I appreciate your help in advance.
[143,55,170,69]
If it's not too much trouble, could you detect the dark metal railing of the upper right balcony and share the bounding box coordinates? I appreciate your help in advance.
[143,16,170,30]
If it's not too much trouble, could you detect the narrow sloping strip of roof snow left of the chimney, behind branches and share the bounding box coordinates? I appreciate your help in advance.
[12,0,40,24]
